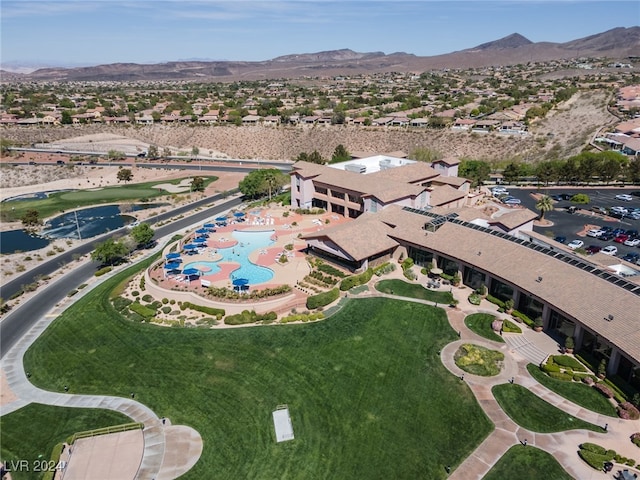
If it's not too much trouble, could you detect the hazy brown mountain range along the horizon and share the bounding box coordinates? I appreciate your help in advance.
[1,26,640,82]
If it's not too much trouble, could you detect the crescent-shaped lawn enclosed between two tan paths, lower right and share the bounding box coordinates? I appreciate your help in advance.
[491,383,605,433]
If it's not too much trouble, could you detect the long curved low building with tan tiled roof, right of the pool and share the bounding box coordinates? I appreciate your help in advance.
[303,204,640,383]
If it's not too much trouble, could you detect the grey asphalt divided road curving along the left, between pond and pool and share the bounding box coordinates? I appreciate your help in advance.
[0,194,243,358]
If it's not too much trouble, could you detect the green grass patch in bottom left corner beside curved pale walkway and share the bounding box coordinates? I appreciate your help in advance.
[0,403,131,480]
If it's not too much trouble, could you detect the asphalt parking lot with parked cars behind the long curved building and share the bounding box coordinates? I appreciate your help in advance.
[496,186,640,258]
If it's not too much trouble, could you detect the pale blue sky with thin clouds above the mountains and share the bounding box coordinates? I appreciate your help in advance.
[0,0,640,66]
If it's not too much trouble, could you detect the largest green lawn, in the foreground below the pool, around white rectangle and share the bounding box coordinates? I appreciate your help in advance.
[18,267,493,480]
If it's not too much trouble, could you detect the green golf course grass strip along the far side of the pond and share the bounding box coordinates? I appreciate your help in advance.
[0,177,218,221]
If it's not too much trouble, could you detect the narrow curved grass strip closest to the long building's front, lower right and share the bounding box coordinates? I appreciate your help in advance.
[527,363,618,417]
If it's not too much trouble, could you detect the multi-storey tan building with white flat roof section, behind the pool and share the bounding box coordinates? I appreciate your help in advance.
[291,155,471,218]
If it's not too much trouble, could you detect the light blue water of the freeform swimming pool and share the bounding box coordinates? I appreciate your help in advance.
[183,230,275,285]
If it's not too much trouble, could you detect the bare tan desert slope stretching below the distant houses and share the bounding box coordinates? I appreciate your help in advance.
[2,91,616,161]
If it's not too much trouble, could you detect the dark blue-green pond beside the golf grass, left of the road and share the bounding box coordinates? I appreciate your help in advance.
[0,203,165,254]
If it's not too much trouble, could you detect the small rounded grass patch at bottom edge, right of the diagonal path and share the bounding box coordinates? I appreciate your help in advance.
[483,445,573,480]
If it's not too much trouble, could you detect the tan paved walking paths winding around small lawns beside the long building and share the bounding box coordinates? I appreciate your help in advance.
[351,272,640,480]
